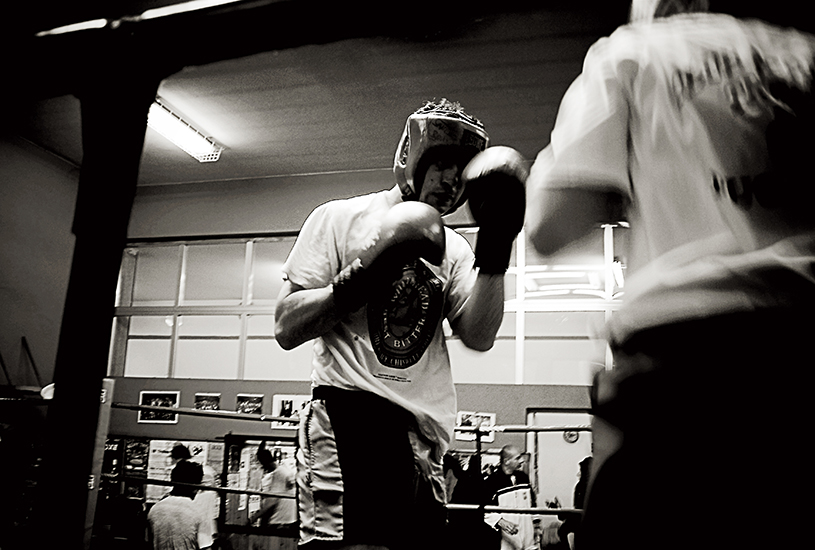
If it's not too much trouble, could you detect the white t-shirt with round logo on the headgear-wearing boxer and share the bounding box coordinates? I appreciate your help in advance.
[283,191,476,462]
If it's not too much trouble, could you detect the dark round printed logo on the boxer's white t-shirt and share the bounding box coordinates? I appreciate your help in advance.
[368,259,443,369]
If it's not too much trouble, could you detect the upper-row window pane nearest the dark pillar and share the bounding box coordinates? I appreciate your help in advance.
[133,245,181,306]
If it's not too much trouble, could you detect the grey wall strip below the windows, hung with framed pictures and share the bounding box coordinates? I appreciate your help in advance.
[109,378,589,450]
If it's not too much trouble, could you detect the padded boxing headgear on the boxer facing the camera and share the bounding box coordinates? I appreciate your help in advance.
[393,99,490,212]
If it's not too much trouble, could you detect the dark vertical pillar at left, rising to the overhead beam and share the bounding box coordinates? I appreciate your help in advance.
[31,52,160,549]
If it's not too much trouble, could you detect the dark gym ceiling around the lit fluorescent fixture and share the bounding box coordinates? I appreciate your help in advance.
[4,0,627,185]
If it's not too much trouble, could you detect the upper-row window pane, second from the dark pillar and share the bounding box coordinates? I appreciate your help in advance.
[184,243,246,305]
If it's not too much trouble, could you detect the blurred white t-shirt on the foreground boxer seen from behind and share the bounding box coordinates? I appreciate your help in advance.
[530,13,815,339]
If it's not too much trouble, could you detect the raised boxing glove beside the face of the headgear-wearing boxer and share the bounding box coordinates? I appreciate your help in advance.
[461,146,529,275]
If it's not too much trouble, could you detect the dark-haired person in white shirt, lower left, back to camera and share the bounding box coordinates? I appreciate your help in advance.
[147,460,205,550]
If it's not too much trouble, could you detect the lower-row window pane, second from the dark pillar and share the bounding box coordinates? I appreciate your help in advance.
[174,315,240,380]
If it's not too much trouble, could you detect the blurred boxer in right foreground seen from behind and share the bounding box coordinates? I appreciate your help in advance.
[527,0,815,550]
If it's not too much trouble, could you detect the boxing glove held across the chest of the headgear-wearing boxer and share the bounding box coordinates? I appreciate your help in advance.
[332,201,445,314]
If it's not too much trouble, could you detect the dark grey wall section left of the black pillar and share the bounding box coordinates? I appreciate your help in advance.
[0,138,79,386]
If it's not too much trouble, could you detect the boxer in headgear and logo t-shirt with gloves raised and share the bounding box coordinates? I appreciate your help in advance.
[275,100,527,549]
